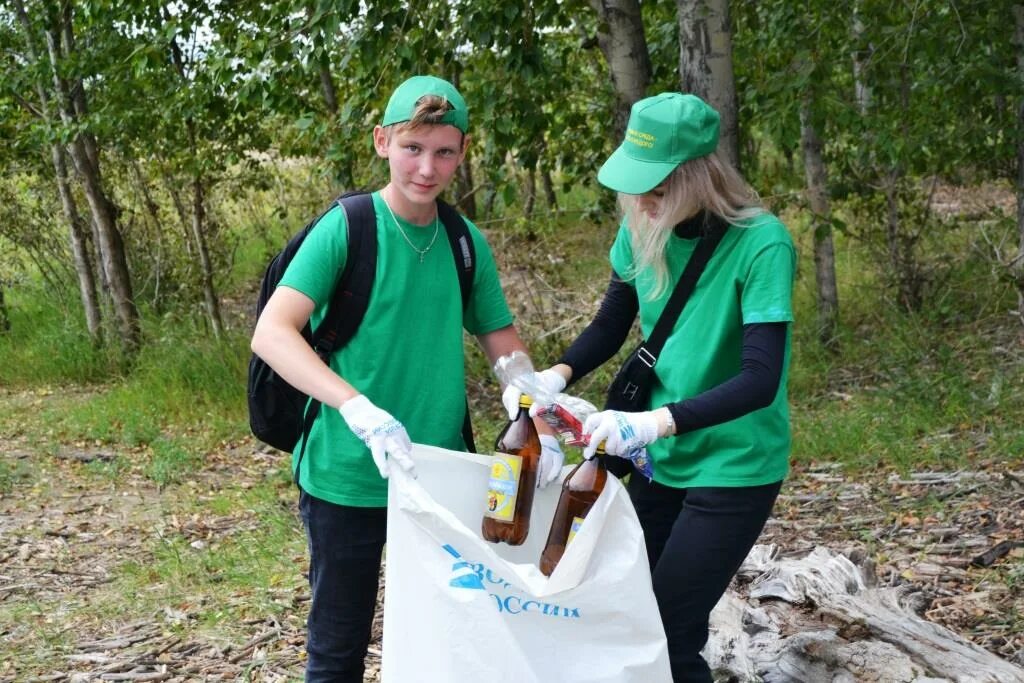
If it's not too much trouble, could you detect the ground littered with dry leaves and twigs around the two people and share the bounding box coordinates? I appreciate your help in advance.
[0,432,1024,681]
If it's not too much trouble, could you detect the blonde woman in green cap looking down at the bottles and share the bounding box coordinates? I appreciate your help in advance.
[539,93,796,683]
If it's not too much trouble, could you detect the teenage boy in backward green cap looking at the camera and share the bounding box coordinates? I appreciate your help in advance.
[252,76,562,683]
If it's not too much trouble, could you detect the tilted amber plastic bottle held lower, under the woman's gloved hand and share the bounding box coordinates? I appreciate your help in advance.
[541,447,608,577]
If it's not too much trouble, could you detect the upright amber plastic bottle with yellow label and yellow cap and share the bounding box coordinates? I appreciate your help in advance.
[480,395,541,546]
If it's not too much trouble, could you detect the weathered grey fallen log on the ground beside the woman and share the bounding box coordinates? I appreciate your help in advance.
[705,546,1024,683]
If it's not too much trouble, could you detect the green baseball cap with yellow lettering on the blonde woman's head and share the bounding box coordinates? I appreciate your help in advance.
[597,92,719,195]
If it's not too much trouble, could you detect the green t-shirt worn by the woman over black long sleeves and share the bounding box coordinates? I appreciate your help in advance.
[610,213,797,487]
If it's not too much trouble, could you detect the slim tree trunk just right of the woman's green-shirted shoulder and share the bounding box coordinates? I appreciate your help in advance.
[800,90,839,349]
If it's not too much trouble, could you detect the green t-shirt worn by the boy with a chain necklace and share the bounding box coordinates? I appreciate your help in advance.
[280,193,512,507]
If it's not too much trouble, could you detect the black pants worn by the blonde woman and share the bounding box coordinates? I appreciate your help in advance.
[629,473,782,683]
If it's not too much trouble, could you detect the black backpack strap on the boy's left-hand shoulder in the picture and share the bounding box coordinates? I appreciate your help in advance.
[295,193,377,485]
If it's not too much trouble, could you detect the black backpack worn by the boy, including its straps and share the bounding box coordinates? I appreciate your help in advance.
[247,193,476,466]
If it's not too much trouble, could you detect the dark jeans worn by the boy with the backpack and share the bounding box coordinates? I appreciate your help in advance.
[299,490,387,683]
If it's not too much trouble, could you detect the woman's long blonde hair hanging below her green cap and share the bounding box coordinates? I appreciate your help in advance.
[618,153,764,300]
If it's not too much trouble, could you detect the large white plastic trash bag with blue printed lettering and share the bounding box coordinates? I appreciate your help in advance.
[382,445,672,683]
